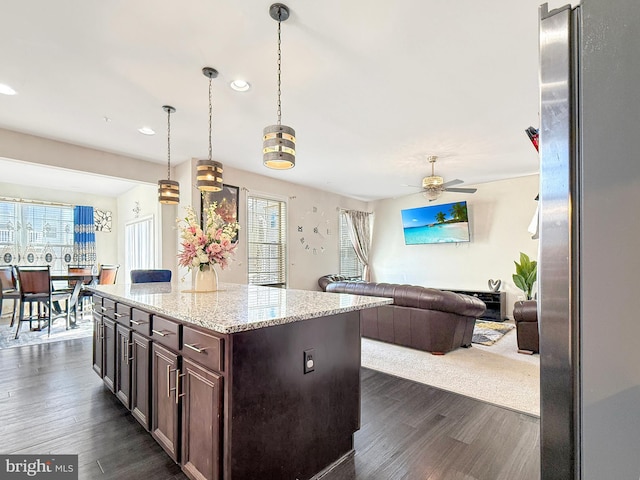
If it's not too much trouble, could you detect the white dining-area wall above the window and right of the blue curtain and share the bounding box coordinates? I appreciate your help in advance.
[0,183,120,270]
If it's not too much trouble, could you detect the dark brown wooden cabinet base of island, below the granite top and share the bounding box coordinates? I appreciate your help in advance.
[93,292,360,480]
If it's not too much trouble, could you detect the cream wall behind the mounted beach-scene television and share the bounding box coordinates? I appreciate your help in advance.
[371,175,538,317]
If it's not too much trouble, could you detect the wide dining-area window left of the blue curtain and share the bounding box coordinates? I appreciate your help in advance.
[0,200,73,273]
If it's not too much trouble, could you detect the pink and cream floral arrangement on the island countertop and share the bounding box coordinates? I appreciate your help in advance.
[177,202,240,291]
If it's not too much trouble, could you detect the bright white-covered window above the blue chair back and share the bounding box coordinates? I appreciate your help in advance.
[124,216,156,279]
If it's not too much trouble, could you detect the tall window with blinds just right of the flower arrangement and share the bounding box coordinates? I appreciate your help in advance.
[247,196,287,288]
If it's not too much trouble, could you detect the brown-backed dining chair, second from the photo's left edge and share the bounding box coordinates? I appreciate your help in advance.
[15,265,71,338]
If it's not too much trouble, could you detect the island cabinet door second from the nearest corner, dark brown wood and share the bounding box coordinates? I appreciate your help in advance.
[151,342,180,462]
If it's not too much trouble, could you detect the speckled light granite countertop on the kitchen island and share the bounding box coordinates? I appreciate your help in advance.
[88,282,393,334]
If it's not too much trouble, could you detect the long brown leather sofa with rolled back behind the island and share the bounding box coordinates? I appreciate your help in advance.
[318,275,486,355]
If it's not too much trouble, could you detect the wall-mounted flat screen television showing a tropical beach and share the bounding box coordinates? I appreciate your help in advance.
[401,202,470,245]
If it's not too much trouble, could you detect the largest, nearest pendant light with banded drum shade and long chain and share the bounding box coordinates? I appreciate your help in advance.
[262,3,296,170]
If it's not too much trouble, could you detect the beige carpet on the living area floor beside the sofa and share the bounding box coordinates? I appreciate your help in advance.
[362,330,540,416]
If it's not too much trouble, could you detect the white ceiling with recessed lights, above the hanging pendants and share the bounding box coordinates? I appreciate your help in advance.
[0,0,555,200]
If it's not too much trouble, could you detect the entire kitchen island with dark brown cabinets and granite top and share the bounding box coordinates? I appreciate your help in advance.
[91,283,392,480]
